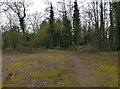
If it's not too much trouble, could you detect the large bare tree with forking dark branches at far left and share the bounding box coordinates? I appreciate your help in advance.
[0,0,29,34]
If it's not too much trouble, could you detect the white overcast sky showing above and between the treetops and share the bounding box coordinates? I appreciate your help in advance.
[0,0,91,25]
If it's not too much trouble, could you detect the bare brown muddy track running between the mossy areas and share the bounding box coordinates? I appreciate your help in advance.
[69,56,96,87]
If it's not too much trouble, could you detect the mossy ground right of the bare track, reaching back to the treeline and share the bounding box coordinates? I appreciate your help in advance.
[77,52,119,87]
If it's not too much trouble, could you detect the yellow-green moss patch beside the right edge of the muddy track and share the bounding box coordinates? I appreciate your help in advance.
[94,61,118,87]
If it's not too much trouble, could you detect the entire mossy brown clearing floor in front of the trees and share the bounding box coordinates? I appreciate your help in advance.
[2,50,118,87]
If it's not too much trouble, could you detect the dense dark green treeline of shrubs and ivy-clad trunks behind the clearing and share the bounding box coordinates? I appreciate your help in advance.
[2,1,120,51]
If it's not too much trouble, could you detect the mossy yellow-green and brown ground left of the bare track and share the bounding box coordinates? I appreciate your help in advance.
[2,51,72,87]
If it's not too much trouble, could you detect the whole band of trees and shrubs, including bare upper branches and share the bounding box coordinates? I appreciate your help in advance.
[0,0,120,51]
